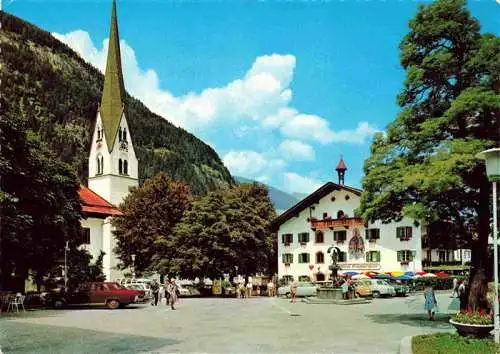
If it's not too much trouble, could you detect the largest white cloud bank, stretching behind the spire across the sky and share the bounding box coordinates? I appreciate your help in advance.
[53,30,376,144]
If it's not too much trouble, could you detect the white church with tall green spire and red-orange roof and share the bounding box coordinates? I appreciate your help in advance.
[76,0,139,281]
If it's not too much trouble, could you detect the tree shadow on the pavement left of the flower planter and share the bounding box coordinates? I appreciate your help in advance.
[365,313,453,330]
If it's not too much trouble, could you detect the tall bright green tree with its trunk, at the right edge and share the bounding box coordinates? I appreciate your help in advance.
[360,0,500,308]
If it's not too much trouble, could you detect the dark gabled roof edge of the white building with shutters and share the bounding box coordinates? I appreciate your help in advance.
[271,182,363,231]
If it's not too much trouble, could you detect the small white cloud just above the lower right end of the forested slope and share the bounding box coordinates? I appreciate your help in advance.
[222,150,286,182]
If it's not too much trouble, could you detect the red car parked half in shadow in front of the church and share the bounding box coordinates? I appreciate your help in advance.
[46,282,145,309]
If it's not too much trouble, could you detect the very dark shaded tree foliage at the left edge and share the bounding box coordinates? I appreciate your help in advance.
[0,99,81,288]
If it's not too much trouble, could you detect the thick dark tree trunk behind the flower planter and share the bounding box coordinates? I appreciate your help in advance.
[467,182,491,310]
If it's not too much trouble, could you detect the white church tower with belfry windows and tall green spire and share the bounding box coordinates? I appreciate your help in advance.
[89,0,139,206]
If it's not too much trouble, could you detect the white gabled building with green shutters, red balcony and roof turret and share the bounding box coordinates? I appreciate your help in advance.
[273,160,422,281]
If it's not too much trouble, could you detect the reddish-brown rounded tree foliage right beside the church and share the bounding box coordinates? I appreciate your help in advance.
[113,173,192,272]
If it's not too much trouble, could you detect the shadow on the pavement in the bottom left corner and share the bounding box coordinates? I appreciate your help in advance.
[1,321,180,354]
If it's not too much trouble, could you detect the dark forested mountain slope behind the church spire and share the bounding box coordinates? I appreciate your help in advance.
[0,12,235,195]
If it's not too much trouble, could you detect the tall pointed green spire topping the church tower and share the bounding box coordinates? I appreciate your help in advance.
[100,0,125,152]
